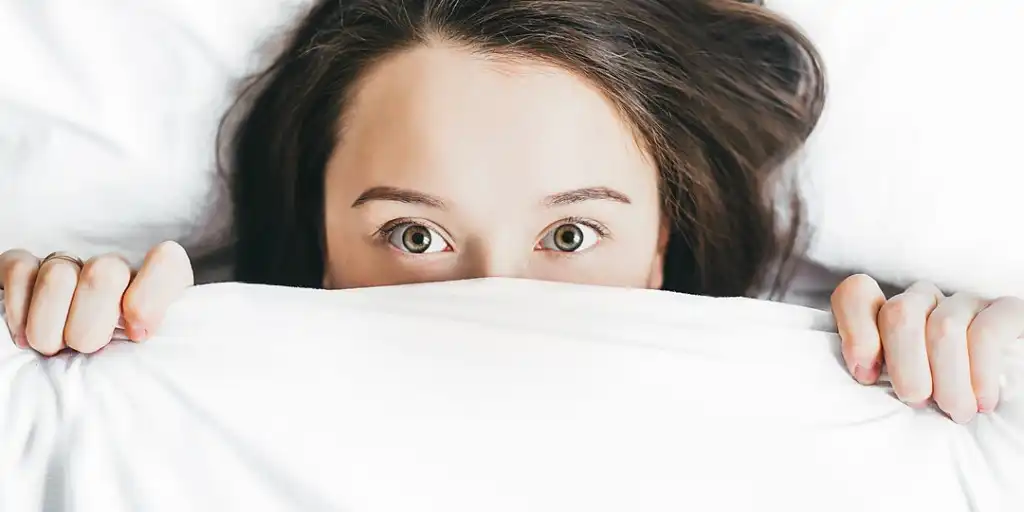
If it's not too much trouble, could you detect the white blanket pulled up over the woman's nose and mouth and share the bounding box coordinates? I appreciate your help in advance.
[0,280,1024,512]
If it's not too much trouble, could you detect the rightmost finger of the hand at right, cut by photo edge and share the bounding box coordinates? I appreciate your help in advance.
[967,297,1024,413]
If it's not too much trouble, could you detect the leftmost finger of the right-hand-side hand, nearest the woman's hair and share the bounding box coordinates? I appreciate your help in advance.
[831,274,886,384]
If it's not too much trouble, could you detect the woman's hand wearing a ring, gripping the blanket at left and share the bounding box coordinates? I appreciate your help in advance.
[0,242,194,355]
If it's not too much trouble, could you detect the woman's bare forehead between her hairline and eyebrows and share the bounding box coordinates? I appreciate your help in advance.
[331,41,656,203]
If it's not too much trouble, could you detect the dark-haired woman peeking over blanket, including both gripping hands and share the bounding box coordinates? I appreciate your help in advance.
[0,0,1024,422]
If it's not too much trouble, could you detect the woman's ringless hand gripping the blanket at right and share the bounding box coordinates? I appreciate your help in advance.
[831,275,1024,423]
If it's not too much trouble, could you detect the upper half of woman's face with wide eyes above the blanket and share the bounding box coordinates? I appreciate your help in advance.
[324,46,668,288]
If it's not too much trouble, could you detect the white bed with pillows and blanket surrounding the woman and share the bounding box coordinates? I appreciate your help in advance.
[0,0,1024,512]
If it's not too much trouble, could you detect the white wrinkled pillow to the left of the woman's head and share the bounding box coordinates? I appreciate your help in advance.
[0,0,310,261]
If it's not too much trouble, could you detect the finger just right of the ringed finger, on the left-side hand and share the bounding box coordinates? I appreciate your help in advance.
[63,255,131,353]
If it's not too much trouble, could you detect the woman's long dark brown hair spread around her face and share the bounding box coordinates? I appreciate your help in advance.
[222,0,824,296]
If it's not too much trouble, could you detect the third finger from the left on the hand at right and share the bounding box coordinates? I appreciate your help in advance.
[927,294,986,423]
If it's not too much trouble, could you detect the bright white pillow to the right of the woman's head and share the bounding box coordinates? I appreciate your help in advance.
[768,0,1024,296]
